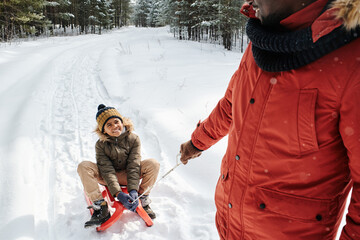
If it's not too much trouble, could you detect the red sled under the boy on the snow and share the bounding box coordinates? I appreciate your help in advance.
[85,185,154,232]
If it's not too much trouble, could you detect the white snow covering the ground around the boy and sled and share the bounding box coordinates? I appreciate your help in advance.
[0,27,348,240]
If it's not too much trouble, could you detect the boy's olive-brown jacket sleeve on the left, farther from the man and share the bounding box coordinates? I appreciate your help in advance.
[95,141,121,196]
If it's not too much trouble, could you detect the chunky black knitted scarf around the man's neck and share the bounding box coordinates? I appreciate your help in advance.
[246,15,360,72]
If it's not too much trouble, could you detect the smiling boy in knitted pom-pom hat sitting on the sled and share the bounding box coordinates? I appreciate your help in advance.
[77,104,160,227]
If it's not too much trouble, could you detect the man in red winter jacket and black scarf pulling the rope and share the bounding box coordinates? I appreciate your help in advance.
[180,0,360,240]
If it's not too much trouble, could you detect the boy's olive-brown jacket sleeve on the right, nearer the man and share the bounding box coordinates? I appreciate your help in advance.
[126,136,141,192]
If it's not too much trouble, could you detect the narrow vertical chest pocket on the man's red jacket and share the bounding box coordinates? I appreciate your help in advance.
[297,89,319,154]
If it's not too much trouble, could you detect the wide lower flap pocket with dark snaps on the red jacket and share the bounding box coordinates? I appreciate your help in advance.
[255,187,338,222]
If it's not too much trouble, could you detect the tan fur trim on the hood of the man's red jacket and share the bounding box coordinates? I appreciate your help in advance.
[332,0,360,30]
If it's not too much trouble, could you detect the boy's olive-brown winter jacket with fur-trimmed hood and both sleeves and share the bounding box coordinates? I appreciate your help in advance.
[95,118,141,195]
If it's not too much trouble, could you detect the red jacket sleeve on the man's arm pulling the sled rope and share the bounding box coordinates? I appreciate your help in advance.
[191,70,239,150]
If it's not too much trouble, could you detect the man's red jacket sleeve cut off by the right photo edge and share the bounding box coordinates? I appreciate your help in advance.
[339,64,360,240]
